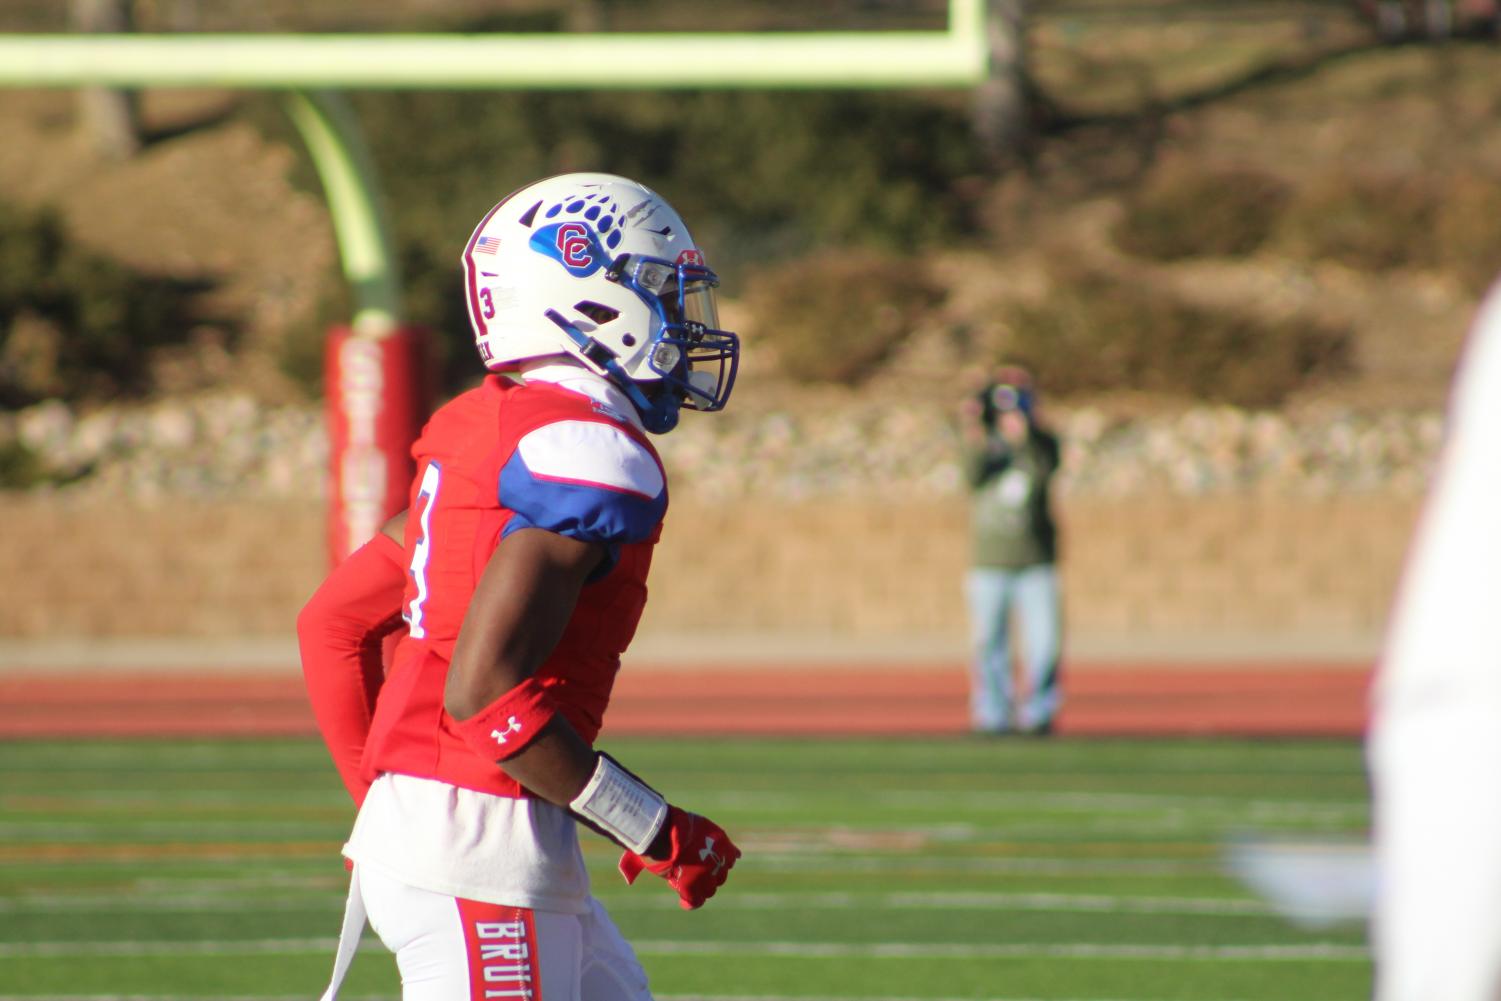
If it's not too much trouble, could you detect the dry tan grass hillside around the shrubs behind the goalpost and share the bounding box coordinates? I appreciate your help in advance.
[0,17,1501,423]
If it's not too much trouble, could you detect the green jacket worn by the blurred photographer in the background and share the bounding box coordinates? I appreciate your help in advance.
[964,426,1058,570]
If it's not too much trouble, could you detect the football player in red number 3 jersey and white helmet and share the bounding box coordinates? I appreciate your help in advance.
[297,174,740,1001]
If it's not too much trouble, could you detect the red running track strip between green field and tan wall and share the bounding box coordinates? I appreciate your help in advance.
[0,663,1370,738]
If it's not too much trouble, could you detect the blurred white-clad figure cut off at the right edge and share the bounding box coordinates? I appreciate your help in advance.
[1367,276,1501,1001]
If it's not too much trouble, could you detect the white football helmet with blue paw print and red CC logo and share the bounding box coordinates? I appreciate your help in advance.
[464,174,740,434]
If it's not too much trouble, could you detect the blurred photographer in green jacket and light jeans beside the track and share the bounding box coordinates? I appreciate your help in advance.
[959,366,1063,735]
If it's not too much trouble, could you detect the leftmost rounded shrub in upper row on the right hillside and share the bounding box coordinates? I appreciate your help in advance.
[1115,162,1291,261]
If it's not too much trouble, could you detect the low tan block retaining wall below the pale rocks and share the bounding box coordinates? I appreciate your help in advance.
[0,494,1418,642]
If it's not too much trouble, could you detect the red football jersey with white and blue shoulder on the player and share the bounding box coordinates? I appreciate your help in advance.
[363,375,666,795]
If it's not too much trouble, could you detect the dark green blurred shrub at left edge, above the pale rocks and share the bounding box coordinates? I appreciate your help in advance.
[0,204,203,407]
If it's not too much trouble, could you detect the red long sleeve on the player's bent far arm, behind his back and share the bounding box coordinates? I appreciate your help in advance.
[297,533,407,804]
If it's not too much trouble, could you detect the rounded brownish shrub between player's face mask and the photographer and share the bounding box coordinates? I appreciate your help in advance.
[746,252,943,386]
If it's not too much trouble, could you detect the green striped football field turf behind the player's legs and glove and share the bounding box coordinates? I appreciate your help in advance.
[0,738,1370,1001]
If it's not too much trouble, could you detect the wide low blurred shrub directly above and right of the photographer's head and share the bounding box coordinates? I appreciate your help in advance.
[1009,266,1351,407]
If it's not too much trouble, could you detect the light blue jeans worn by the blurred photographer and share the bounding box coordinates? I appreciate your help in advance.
[965,563,1063,731]
